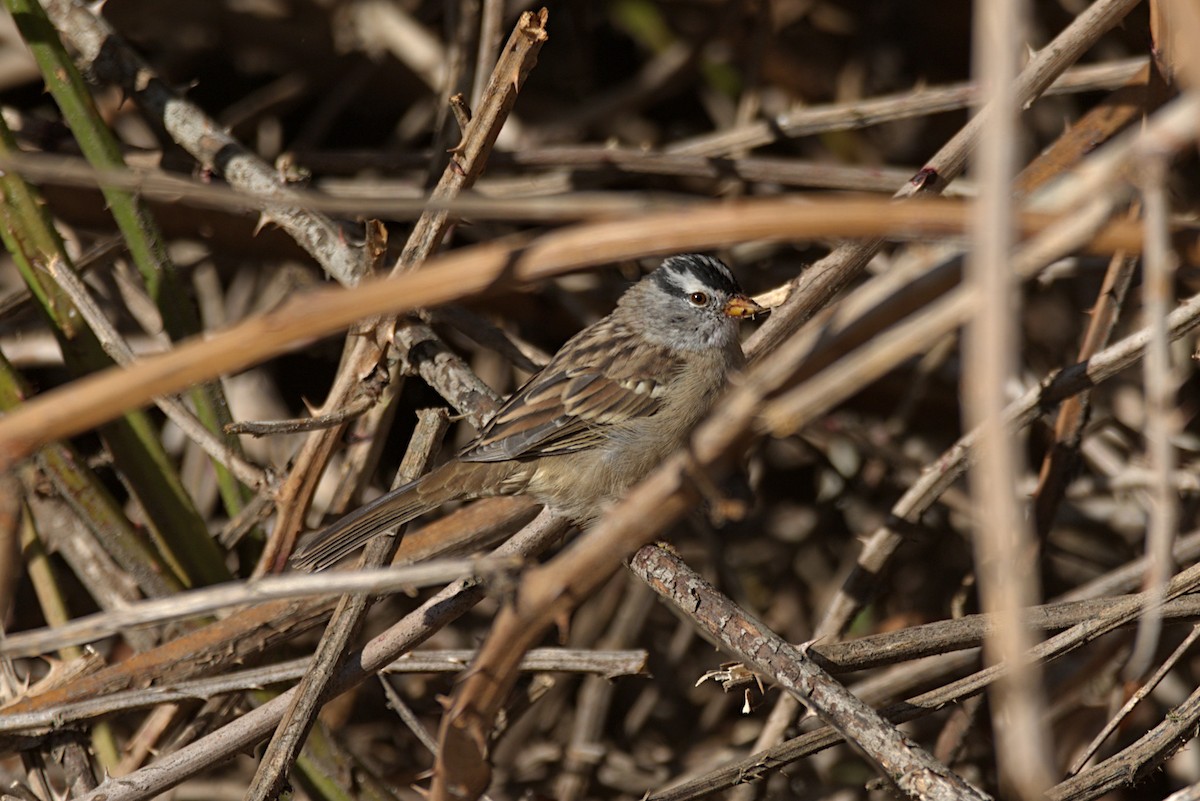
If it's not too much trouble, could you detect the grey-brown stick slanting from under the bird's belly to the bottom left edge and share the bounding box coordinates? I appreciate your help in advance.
[69,514,565,801]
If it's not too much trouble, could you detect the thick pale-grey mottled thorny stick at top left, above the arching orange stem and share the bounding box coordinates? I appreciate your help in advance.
[42,0,368,283]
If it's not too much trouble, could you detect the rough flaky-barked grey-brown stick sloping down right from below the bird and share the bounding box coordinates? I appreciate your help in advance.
[629,546,989,800]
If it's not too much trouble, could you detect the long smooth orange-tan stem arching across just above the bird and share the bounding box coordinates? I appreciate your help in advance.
[0,199,1141,479]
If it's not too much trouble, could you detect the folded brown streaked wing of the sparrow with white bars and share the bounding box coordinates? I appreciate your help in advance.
[458,330,679,462]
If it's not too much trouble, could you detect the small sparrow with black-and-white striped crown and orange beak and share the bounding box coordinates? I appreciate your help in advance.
[293,254,766,570]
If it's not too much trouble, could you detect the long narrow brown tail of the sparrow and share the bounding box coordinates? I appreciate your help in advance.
[292,462,520,571]
